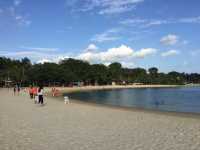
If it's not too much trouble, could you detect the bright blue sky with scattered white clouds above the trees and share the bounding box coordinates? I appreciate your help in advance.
[0,0,200,73]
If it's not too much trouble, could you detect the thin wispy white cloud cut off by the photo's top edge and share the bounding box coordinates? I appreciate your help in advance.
[67,0,144,15]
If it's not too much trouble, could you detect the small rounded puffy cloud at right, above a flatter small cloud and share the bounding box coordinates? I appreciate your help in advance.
[160,34,179,45]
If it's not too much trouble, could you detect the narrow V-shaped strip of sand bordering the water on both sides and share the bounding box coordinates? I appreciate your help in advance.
[50,85,200,119]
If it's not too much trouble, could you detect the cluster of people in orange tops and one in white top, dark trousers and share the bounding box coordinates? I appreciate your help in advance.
[29,86,44,105]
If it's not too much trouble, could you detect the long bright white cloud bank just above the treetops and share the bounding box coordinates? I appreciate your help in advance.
[0,44,157,67]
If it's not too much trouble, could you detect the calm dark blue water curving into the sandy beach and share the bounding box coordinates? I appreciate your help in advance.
[67,87,200,113]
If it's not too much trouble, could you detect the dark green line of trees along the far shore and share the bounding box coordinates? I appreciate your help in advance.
[0,57,200,86]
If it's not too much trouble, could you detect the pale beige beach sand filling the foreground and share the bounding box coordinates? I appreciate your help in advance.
[0,89,200,150]
